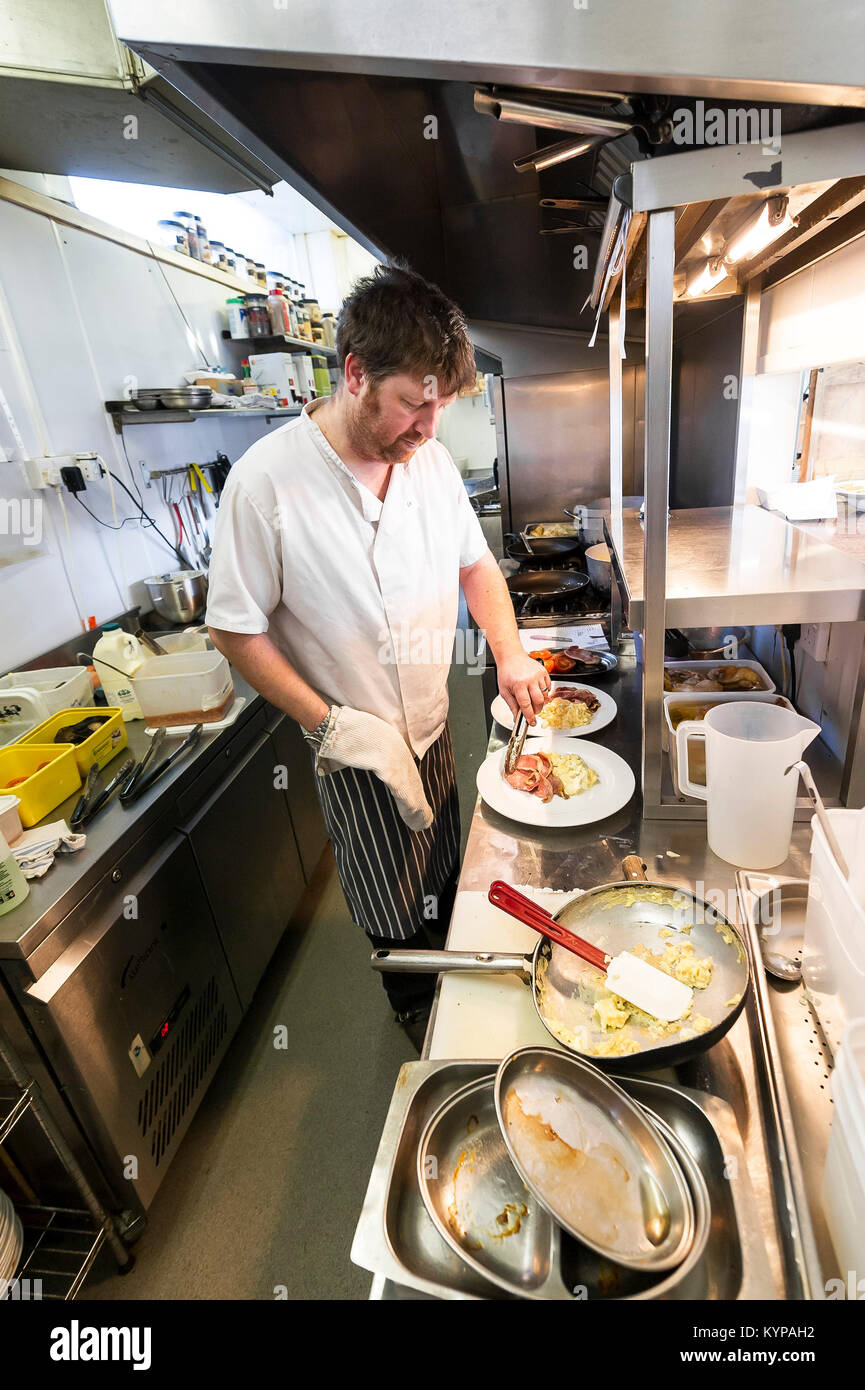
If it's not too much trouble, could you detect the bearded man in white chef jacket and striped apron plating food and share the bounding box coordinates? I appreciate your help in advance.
[207,264,549,1037]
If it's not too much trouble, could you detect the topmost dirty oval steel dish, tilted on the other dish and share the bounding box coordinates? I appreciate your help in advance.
[495,1047,695,1272]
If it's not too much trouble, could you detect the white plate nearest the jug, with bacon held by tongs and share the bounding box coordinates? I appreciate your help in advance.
[477,730,636,827]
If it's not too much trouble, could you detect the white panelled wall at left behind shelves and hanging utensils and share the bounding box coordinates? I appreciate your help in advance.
[0,190,308,670]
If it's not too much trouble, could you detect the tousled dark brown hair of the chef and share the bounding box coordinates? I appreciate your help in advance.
[337,261,474,396]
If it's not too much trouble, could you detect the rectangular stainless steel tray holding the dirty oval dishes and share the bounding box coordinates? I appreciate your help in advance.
[352,1062,777,1300]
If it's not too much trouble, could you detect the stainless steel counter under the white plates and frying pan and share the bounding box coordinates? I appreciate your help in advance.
[371,644,834,1298]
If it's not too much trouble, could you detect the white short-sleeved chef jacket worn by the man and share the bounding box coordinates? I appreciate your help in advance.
[201,402,487,758]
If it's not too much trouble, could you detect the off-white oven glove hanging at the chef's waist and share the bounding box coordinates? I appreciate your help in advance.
[316,705,433,830]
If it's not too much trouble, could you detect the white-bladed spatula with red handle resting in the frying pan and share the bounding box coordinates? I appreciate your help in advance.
[488,878,694,1023]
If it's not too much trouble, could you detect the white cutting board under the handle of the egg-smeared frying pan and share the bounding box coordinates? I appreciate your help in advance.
[430,887,576,1062]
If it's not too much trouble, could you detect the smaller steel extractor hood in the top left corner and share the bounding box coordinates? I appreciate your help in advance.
[0,0,277,193]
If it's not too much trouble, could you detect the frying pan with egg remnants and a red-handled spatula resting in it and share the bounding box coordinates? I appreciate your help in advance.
[371,855,751,1072]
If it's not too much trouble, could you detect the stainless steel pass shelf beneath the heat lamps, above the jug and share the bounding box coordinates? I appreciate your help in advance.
[606,506,865,631]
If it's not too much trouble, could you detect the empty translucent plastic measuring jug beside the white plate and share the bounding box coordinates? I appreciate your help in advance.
[676,701,820,869]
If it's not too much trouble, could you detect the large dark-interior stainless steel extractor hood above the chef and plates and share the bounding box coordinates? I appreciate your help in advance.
[104,0,865,329]
